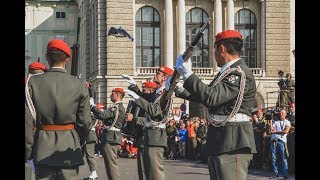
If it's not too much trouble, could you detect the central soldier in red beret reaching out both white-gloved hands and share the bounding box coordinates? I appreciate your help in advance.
[123,66,173,180]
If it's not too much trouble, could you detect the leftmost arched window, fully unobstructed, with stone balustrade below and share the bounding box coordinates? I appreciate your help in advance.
[135,6,160,67]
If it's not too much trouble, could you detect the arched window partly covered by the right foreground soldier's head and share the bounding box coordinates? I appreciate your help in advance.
[234,9,257,68]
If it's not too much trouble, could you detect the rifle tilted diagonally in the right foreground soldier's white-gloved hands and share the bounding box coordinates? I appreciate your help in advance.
[160,18,211,111]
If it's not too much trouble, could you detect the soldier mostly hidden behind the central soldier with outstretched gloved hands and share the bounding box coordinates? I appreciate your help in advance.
[127,81,158,180]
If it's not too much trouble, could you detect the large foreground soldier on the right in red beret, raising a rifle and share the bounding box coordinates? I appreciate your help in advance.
[175,30,256,180]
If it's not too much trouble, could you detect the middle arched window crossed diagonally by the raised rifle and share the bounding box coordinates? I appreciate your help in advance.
[186,8,209,67]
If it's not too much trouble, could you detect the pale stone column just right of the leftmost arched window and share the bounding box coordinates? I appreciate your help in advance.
[164,0,173,68]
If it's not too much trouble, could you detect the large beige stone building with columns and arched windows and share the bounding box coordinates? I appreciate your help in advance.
[26,0,295,115]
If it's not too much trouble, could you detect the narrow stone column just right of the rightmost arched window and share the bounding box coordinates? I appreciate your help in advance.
[260,0,266,69]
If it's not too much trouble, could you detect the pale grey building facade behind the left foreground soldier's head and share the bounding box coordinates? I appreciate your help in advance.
[25,0,78,74]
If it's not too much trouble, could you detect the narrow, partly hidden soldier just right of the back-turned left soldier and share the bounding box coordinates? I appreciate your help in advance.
[84,103,104,180]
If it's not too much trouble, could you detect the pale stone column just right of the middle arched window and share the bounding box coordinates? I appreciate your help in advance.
[213,0,222,70]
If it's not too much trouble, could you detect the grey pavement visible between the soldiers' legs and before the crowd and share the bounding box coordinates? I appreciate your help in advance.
[79,158,295,180]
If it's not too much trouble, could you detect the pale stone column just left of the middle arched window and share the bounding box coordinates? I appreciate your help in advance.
[177,0,186,56]
